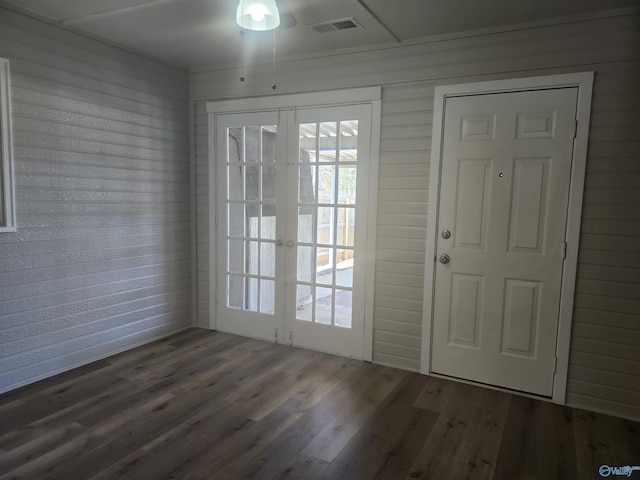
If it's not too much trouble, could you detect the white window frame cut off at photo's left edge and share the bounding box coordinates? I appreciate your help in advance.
[0,58,16,232]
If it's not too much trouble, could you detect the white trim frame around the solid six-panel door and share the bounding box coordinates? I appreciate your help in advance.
[420,72,593,404]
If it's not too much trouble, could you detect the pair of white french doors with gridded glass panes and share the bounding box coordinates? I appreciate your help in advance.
[215,105,371,358]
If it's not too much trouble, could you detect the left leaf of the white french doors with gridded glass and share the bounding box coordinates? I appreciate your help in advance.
[216,111,286,339]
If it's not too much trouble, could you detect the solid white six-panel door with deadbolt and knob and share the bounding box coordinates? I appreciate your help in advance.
[431,88,578,396]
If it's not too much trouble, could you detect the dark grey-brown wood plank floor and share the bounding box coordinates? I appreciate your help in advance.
[0,329,640,480]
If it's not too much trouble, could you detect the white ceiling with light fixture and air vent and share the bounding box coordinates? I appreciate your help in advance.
[5,0,638,68]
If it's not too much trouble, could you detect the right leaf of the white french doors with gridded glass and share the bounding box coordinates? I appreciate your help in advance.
[286,105,371,358]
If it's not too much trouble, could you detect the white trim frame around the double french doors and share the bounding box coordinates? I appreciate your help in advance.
[207,87,382,361]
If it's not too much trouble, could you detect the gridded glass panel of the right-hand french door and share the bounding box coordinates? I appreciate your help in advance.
[296,120,358,328]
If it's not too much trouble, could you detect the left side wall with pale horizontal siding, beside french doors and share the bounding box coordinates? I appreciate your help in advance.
[0,8,191,392]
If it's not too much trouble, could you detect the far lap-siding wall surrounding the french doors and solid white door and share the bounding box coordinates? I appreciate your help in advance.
[191,11,640,419]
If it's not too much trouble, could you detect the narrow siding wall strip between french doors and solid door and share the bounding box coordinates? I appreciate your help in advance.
[373,82,434,371]
